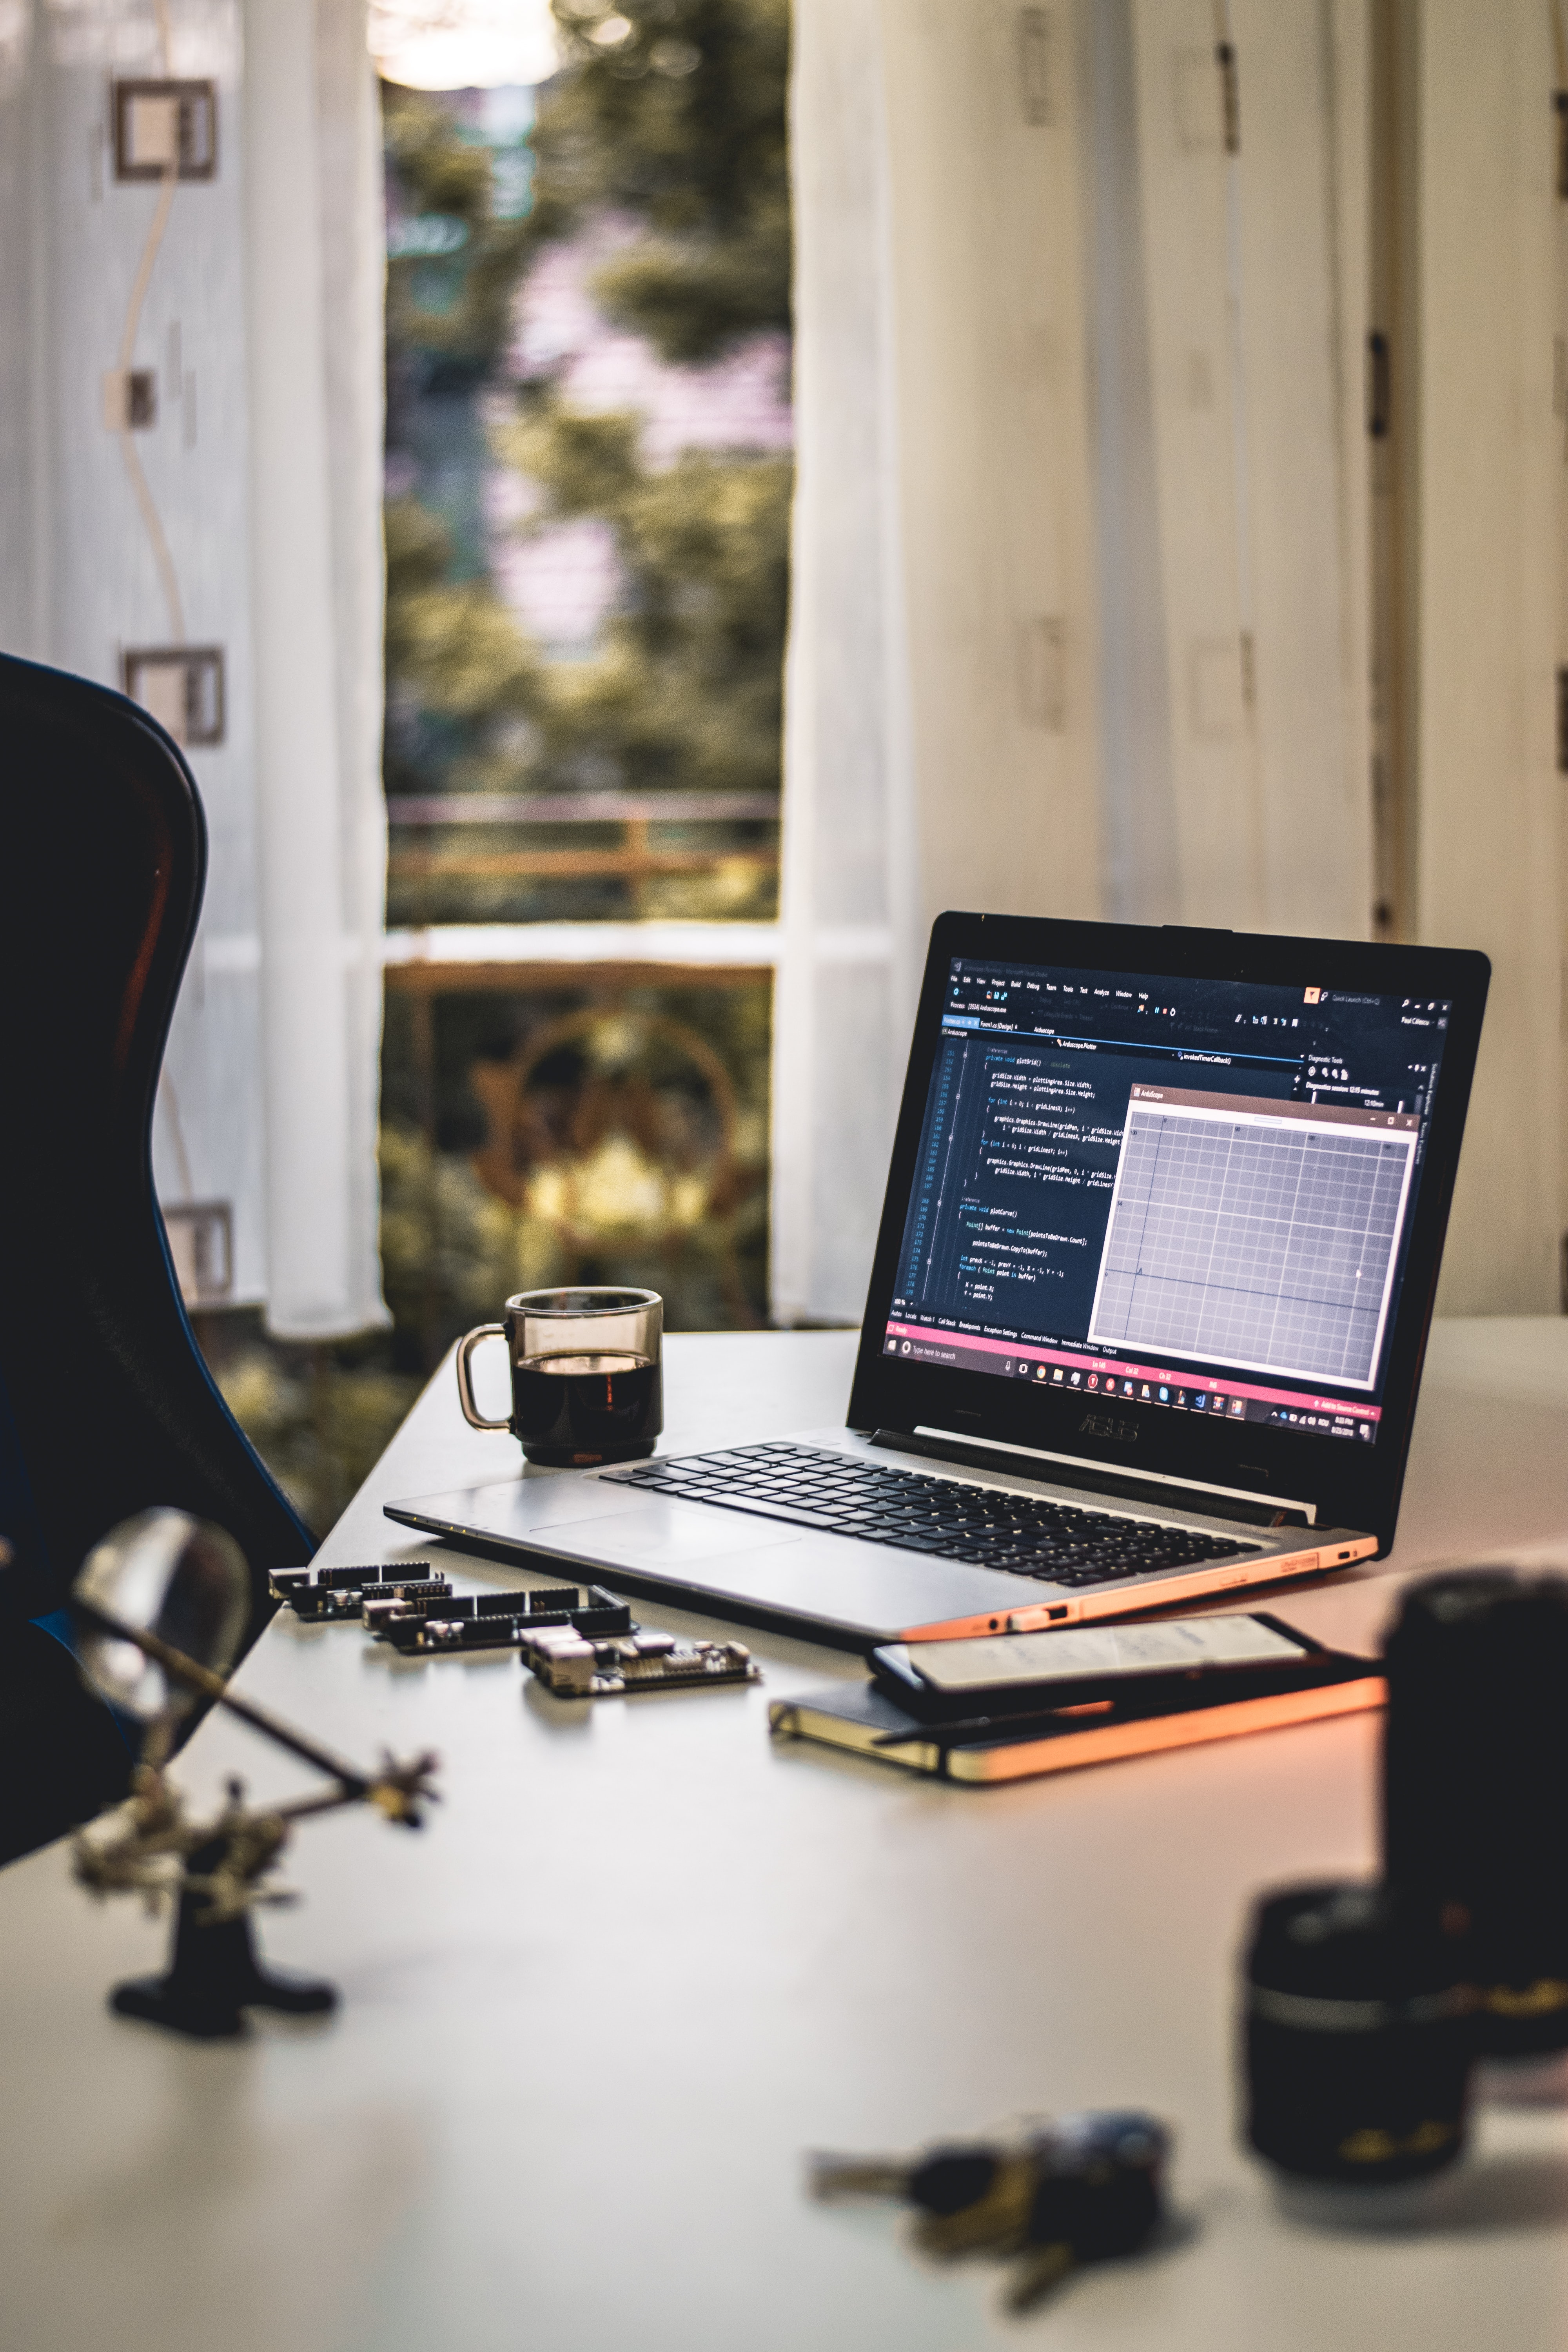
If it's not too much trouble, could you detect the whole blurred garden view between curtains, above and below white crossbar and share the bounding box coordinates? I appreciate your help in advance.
[219,0,792,1526]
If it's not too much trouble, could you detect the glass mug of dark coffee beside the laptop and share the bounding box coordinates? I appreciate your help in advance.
[458,1287,665,1468]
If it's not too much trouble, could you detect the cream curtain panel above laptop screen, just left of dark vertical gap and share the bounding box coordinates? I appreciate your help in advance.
[1123,0,1370,936]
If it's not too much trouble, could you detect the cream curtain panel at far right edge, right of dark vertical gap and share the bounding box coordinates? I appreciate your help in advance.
[1415,0,1568,1315]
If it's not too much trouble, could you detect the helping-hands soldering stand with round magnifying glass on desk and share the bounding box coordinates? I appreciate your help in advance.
[73,1512,435,2042]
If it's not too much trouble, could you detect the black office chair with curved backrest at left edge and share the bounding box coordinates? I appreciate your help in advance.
[0,654,315,1860]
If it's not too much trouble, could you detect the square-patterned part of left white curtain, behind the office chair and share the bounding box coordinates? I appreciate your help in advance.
[0,0,268,1301]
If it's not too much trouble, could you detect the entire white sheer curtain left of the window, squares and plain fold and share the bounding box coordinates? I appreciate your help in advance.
[0,0,383,1336]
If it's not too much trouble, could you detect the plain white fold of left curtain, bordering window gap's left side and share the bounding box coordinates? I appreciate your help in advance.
[245,0,386,1338]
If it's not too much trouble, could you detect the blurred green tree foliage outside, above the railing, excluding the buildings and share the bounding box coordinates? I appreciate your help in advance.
[386,0,792,828]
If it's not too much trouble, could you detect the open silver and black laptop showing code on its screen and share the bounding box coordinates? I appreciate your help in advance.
[386,913,1490,1649]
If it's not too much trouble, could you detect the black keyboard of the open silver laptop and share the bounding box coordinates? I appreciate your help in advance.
[604,1439,1262,1585]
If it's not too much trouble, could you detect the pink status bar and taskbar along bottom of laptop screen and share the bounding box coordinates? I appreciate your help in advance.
[882,1322,1382,1444]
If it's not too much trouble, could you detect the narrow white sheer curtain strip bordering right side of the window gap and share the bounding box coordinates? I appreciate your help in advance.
[771,0,922,1322]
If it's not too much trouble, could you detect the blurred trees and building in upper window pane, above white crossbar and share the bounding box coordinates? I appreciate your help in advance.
[386,0,790,924]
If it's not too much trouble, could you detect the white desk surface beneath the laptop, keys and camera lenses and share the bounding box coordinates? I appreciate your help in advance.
[0,1322,1568,2352]
